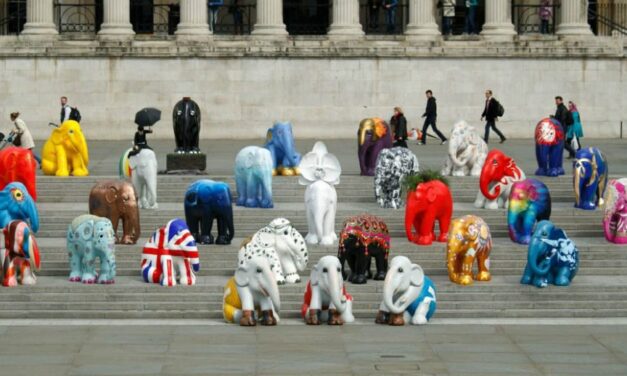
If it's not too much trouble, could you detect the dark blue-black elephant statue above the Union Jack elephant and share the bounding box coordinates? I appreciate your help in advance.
[185,179,234,244]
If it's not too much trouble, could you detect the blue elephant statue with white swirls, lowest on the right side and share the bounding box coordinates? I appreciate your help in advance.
[520,221,579,287]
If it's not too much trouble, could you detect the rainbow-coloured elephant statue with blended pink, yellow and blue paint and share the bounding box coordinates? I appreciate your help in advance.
[507,179,551,244]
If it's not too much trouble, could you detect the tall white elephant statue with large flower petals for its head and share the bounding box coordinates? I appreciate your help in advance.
[298,141,342,245]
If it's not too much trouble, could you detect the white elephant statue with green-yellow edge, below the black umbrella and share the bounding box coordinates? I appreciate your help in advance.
[128,148,159,209]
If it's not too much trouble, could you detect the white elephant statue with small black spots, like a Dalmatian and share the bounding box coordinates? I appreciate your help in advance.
[237,218,309,285]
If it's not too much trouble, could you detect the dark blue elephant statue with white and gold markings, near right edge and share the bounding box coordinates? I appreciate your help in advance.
[573,148,608,210]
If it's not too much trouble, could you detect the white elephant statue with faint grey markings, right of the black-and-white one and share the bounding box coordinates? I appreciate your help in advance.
[441,120,488,176]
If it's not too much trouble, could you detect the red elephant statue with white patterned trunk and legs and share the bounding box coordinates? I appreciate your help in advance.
[475,149,525,210]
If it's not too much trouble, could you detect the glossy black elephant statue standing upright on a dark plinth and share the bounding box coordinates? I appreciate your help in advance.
[172,97,200,153]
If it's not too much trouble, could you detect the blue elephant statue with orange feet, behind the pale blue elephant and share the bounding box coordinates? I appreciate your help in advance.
[264,122,300,176]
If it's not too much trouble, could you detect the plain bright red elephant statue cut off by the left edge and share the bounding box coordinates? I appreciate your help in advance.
[0,146,37,200]
